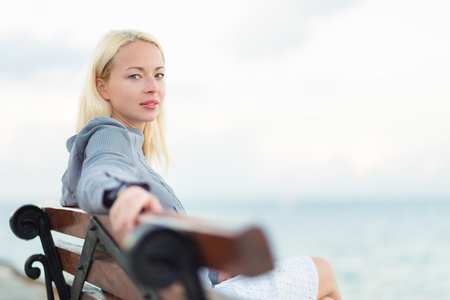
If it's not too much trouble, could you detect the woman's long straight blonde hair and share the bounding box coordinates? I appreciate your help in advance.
[77,30,169,169]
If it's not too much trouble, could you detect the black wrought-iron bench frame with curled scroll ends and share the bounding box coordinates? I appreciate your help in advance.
[10,205,206,300]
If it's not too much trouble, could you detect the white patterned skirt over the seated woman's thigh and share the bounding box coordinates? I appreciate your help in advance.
[215,256,319,300]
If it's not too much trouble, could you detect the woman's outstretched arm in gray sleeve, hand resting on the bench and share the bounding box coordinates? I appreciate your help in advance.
[62,117,168,242]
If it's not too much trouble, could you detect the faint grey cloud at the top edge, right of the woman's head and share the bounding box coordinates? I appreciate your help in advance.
[213,0,360,60]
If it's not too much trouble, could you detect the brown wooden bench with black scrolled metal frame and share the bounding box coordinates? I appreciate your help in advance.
[10,205,273,300]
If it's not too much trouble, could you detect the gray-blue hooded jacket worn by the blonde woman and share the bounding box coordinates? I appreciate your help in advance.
[61,117,185,213]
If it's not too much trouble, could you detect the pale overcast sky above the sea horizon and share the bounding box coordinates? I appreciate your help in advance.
[0,0,450,204]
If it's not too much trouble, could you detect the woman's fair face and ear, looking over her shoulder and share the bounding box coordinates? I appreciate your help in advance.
[96,41,166,130]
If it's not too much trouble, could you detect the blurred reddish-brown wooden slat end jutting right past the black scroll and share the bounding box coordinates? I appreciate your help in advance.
[95,214,273,276]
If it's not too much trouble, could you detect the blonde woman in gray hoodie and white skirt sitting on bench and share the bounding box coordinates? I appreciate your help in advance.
[61,31,341,300]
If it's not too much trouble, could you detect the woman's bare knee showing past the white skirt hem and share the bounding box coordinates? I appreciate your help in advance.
[312,257,342,300]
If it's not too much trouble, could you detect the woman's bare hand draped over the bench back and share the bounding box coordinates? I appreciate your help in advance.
[109,186,163,246]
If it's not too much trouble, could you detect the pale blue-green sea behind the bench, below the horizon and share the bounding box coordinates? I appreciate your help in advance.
[0,201,450,300]
